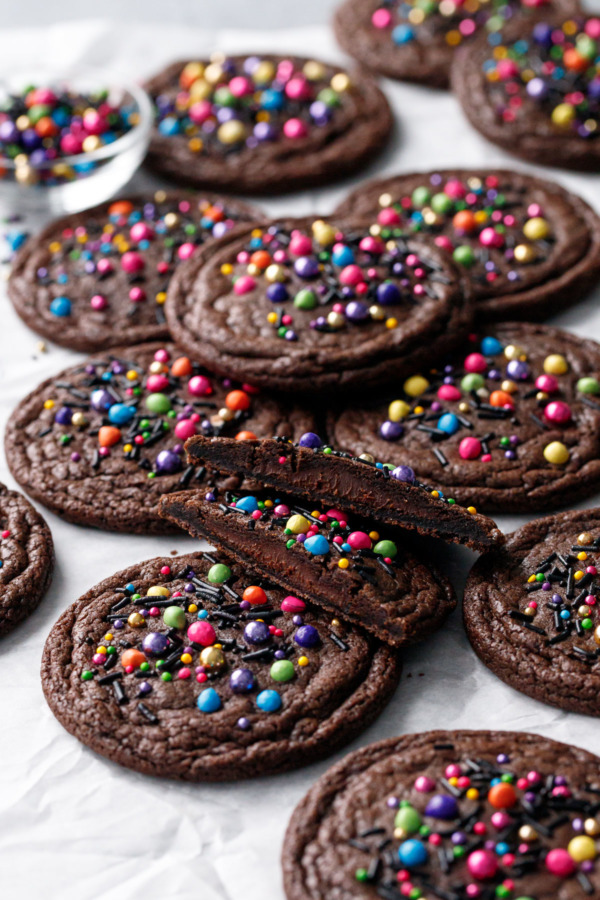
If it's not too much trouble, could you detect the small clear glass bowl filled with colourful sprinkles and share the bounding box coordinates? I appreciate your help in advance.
[0,72,152,215]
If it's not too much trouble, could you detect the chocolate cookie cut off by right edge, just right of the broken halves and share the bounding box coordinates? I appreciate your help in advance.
[464,509,600,716]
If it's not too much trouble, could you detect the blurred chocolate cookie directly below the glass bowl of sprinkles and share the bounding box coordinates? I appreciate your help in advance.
[8,191,262,353]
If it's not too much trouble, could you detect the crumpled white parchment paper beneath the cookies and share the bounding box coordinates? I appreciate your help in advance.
[0,19,600,900]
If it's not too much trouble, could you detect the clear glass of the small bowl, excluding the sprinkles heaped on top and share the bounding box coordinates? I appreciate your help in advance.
[0,70,153,218]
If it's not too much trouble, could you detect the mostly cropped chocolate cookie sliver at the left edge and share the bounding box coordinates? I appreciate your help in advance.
[0,484,54,635]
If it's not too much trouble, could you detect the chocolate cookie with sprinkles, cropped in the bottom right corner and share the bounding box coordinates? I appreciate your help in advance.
[283,731,600,900]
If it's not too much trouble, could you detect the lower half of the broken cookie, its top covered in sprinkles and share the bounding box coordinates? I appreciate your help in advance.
[160,491,456,647]
